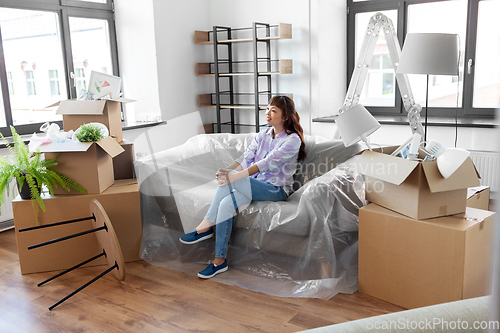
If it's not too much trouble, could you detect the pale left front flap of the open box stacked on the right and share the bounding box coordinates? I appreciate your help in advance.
[354,149,419,185]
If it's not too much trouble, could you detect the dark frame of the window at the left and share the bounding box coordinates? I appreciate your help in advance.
[0,0,120,136]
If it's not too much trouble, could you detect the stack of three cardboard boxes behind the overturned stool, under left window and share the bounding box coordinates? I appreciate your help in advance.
[12,100,142,274]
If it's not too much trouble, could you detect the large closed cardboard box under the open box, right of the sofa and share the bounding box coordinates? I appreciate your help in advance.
[358,204,495,309]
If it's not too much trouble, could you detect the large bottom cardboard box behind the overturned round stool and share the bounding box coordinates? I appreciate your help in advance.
[12,179,142,274]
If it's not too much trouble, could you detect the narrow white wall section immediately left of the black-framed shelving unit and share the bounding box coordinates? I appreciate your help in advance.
[149,0,213,121]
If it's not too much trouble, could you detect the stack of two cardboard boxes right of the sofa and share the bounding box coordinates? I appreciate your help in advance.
[357,147,494,309]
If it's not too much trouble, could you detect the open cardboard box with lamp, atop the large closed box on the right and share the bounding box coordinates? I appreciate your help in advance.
[355,147,479,219]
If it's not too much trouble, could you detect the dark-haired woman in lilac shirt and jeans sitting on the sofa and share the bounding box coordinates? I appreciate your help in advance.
[180,96,306,279]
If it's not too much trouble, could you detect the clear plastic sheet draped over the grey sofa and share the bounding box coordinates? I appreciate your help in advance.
[135,133,365,299]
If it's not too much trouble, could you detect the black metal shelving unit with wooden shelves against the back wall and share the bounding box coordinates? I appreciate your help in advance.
[195,22,293,133]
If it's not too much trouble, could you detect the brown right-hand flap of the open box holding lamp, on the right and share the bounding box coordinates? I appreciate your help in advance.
[422,158,479,193]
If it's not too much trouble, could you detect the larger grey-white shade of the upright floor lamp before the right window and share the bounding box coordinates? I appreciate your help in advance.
[396,33,459,75]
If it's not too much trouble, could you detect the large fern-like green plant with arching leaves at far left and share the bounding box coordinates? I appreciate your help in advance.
[0,126,87,224]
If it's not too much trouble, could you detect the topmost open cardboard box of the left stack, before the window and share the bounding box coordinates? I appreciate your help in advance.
[48,98,134,142]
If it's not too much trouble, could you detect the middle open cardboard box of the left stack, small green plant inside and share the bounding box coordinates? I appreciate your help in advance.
[40,136,124,194]
